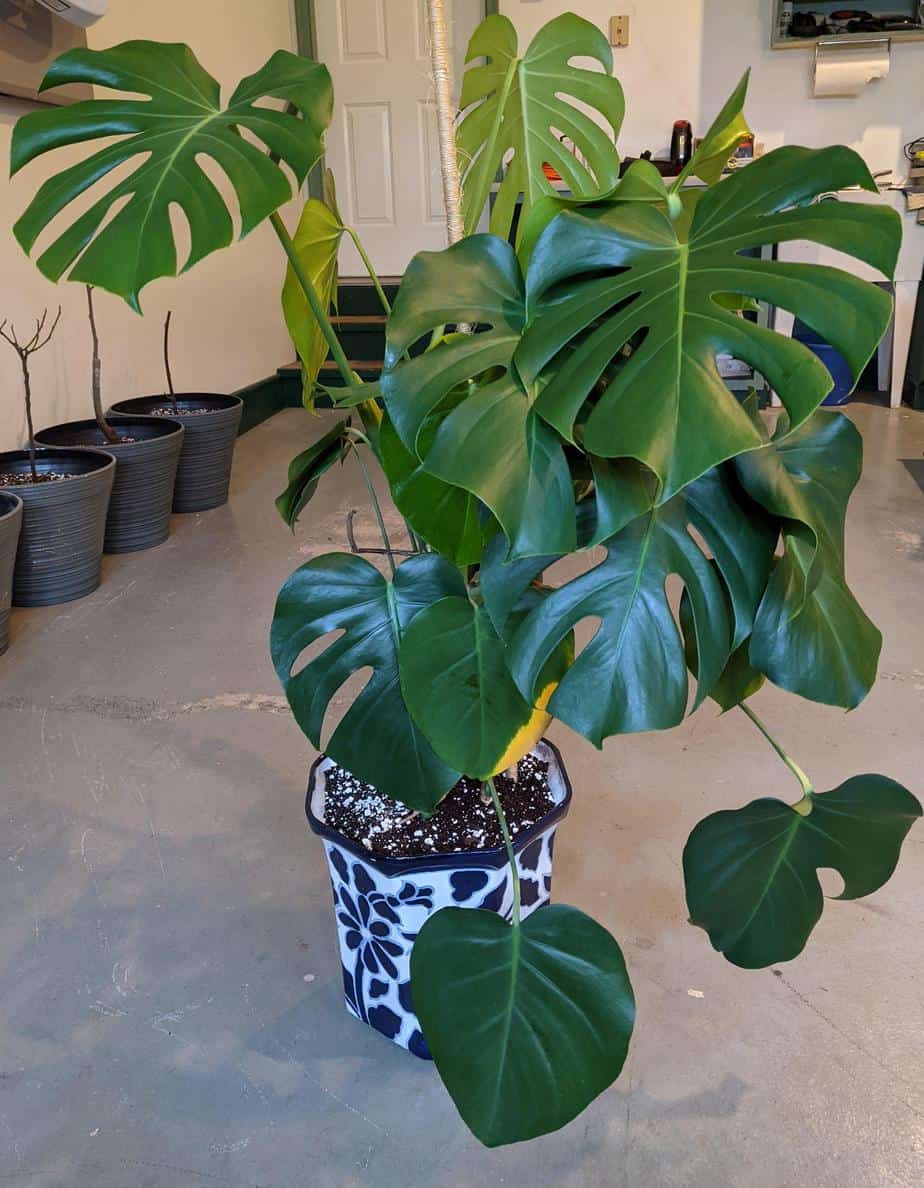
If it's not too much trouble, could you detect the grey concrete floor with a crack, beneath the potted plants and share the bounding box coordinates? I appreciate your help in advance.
[0,405,924,1188]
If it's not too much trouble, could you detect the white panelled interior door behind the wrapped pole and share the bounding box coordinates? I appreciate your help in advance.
[315,0,485,277]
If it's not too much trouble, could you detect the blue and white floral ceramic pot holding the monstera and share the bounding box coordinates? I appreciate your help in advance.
[305,740,571,1060]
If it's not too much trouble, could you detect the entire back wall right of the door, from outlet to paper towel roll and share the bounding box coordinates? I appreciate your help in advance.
[500,0,924,171]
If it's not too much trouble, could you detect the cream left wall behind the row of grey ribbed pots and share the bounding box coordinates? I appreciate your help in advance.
[0,0,295,449]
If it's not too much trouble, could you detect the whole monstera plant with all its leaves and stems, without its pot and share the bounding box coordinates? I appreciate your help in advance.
[13,14,922,1145]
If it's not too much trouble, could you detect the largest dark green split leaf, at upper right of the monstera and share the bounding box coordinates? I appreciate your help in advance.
[515,147,901,500]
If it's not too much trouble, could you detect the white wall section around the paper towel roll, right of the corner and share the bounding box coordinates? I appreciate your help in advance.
[702,0,924,180]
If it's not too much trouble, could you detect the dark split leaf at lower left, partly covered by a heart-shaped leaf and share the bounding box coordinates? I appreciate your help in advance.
[270,552,464,813]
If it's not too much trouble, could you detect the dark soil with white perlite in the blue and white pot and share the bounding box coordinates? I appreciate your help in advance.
[324,754,555,858]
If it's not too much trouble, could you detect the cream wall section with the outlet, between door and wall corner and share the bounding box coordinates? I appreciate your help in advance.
[500,0,703,157]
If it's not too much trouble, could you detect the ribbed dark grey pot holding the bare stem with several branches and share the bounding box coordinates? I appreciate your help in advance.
[0,449,115,606]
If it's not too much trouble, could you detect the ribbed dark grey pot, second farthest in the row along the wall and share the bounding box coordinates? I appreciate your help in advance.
[36,417,184,552]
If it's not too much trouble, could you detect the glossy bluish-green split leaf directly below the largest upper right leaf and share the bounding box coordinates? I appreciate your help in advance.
[510,463,777,746]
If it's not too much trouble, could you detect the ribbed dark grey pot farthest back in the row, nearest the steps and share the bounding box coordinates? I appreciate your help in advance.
[112,392,243,512]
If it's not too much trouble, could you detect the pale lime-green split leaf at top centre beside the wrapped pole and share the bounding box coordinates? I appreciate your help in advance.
[457,13,625,239]
